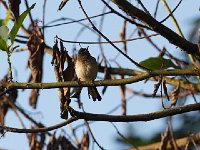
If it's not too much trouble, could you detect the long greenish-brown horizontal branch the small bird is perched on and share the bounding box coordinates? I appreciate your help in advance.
[0,69,200,91]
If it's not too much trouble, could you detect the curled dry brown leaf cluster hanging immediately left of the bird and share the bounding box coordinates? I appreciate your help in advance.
[51,38,75,119]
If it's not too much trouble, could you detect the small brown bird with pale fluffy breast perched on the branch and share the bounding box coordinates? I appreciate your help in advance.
[75,48,101,101]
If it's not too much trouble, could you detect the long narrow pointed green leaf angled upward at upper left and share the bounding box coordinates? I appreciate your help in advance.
[10,3,36,44]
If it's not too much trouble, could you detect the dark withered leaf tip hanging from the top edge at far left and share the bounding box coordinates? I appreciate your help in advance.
[8,0,21,20]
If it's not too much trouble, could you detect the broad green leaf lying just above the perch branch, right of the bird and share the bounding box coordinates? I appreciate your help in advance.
[139,57,180,70]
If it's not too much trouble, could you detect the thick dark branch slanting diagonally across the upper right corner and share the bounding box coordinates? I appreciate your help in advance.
[112,0,199,54]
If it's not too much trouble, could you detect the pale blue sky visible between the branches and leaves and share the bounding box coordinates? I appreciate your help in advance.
[0,0,200,150]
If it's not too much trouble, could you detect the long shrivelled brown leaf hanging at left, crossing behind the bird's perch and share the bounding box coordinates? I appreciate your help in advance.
[27,25,45,108]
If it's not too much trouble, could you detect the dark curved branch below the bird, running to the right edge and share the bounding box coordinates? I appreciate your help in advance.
[67,103,200,122]
